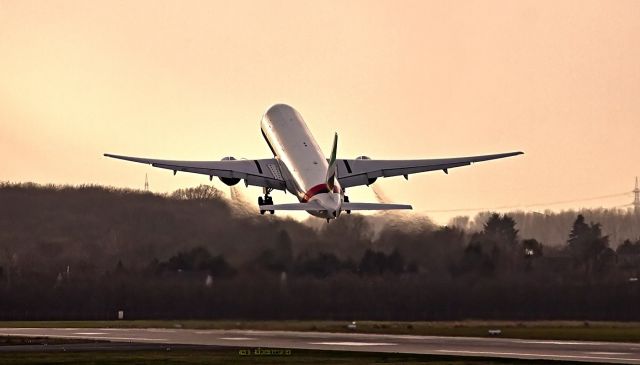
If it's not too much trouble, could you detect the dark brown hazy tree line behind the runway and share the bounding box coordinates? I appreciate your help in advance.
[0,183,640,320]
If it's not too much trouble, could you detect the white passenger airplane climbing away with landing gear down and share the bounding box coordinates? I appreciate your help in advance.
[104,104,523,222]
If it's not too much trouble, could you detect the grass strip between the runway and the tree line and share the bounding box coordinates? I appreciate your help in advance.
[0,320,640,342]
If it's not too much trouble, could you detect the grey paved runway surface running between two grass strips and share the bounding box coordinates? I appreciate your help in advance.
[0,328,640,364]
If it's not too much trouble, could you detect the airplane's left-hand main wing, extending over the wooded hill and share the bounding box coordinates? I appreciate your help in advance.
[104,153,286,190]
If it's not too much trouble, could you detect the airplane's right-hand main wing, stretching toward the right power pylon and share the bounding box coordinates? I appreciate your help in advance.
[337,152,523,188]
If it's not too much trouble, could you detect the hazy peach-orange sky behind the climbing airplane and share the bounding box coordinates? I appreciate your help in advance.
[0,0,640,223]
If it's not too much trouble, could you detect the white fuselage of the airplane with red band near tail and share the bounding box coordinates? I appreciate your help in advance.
[260,104,343,218]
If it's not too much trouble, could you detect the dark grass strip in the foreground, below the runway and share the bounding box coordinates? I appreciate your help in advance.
[0,349,588,365]
